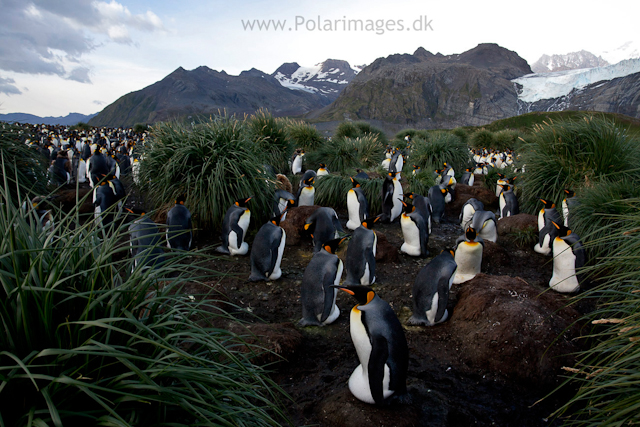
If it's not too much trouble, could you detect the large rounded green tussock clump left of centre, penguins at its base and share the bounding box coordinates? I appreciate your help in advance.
[140,116,275,230]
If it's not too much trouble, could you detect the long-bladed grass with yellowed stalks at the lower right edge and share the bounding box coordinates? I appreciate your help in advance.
[554,198,640,426]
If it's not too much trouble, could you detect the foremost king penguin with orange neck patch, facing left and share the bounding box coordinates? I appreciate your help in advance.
[337,286,409,405]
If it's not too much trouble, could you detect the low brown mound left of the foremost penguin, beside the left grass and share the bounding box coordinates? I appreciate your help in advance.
[229,322,302,364]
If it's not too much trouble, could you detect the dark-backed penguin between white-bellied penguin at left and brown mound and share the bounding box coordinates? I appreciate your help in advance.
[249,208,287,282]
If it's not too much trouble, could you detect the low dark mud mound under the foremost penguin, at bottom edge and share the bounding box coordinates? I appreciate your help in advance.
[316,392,424,427]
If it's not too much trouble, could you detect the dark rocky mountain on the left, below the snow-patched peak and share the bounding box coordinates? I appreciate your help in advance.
[89,66,331,127]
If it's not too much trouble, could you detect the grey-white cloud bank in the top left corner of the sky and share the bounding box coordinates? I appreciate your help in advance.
[0,0,165,83]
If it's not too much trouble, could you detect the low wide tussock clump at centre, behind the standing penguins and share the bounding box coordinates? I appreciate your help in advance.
[306,135,384,172]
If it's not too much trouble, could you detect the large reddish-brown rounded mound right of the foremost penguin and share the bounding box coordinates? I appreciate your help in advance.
[450,273,580,386]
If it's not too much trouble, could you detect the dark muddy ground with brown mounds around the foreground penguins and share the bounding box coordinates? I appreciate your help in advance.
[181,179,589,427]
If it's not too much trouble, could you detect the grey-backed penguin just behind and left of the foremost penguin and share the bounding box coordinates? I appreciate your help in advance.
[299,239,344,326]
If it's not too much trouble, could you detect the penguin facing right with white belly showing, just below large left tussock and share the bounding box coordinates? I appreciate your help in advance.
[216,196,253,256]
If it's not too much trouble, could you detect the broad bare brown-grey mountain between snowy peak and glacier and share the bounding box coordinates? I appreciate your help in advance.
[309,44,531,128]
